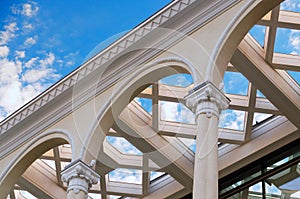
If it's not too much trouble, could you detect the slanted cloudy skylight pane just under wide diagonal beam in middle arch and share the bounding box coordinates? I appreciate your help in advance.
[106,136,142,155]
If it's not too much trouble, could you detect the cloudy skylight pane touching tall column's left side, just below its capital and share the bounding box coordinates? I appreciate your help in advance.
[159,101,195,124]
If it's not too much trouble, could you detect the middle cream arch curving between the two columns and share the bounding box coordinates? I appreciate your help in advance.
[81,57,197,167]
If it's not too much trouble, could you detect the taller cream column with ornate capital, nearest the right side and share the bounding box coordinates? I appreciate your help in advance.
[185,82,230,199]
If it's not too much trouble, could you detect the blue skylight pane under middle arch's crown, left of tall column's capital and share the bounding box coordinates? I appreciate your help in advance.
[159,74,194,88]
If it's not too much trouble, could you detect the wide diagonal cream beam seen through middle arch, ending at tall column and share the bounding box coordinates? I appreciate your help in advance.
[114,104,193,189]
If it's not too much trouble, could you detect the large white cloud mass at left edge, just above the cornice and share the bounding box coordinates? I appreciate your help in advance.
[0,51,60,120]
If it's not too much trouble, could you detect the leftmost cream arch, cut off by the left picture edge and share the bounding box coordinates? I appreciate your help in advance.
[0,131,71,198]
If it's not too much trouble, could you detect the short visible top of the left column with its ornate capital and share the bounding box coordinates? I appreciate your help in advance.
[61,160,100,199]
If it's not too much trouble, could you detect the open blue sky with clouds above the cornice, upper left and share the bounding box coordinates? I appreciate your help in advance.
[0,0,170,120]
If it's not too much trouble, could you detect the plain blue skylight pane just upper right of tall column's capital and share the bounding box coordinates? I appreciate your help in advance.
[224,71,249,96]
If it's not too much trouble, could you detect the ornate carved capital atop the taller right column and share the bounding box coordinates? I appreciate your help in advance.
[185,81,230,118]
